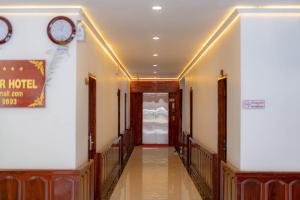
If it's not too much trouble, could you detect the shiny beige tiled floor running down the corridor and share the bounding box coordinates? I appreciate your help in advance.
[111,147,201,200]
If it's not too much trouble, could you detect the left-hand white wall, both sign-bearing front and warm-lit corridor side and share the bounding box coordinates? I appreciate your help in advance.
[0,11,130,169]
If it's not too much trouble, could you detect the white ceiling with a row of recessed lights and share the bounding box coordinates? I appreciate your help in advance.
[0,0,300,78]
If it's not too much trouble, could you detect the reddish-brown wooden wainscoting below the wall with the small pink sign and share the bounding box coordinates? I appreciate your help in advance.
[221,162,300,200]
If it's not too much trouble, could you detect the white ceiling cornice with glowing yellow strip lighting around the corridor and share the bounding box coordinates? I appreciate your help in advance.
[0,5,300,80]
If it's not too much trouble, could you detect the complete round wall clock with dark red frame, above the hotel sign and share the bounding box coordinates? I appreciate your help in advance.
[47,16,76,45]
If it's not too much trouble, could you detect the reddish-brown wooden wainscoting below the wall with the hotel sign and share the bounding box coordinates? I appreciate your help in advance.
[0,161,94,200]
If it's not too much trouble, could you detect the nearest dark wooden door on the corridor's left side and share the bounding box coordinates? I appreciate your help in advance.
[88,76,97,159]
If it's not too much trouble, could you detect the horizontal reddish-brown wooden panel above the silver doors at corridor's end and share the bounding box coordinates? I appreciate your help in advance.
[130,80,179,93]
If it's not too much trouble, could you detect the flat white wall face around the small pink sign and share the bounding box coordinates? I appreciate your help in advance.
[241,15,300,171]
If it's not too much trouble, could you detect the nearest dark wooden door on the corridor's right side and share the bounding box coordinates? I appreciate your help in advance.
[218,78,227,162]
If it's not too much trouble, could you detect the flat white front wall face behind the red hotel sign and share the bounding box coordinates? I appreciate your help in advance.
[0,14,76,169]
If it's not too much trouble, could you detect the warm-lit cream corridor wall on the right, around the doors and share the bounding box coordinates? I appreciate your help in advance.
[183,20,241,167]
